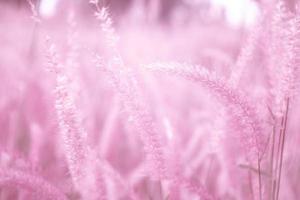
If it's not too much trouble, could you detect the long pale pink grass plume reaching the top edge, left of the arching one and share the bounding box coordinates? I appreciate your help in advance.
[90,1,165,179]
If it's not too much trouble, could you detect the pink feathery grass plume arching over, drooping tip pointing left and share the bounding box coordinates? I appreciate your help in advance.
[146,62,265,159]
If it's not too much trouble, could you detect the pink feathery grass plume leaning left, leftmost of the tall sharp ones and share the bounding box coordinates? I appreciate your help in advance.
[44,40,105,200]
